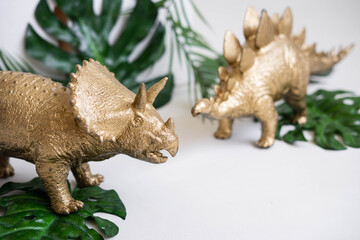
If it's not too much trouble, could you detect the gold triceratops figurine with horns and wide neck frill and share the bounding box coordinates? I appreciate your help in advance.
[0,59,178,214]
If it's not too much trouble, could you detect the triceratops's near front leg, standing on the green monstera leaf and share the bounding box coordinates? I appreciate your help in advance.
[35,161,84,215]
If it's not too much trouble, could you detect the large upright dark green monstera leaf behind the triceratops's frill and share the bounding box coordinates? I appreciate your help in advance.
[26,0,174,107]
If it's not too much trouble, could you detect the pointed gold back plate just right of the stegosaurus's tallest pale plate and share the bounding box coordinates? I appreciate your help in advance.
[255,10,275,48]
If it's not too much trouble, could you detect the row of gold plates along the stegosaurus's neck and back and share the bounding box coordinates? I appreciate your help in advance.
[214,7,296,101]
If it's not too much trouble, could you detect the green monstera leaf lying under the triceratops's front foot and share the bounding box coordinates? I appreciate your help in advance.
[0,178,126,240]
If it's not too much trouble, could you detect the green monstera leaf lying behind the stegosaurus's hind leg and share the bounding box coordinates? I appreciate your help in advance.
[276,89,360,150]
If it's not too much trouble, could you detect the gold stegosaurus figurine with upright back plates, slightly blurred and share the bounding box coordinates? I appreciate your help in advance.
[192,7,352,148]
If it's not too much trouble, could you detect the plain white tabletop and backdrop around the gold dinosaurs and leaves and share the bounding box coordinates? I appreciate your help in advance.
[0,0,360,240]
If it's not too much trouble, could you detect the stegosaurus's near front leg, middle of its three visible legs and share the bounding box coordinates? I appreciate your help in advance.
[255,97,278,148]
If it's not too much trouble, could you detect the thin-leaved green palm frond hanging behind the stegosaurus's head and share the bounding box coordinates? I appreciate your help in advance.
[167,0,225,99]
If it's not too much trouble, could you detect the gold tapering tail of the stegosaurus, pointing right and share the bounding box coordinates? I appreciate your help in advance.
[310,44,354,74]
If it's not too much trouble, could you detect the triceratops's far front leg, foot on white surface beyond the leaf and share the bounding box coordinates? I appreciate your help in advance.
[71,163,104,187]
